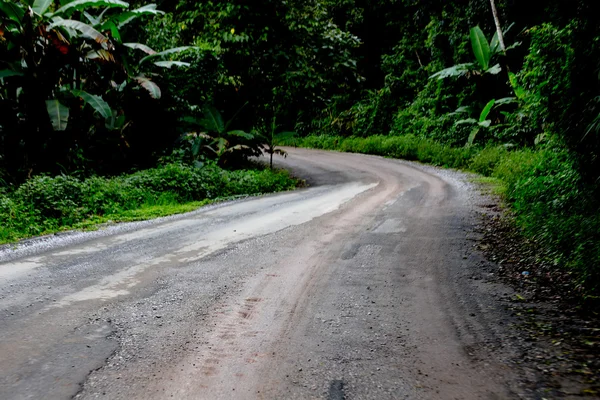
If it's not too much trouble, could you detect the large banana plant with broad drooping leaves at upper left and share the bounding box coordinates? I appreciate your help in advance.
[0,0,189,131]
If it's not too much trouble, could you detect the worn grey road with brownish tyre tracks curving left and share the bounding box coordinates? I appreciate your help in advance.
[0,149,515,400]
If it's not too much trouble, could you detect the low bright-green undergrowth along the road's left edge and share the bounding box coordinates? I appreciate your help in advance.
[0,164,296,243]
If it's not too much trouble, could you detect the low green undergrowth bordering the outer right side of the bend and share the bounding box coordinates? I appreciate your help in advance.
[294,135,600,300]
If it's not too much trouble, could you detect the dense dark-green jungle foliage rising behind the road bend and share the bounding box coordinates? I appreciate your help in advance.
[0,0,600,296]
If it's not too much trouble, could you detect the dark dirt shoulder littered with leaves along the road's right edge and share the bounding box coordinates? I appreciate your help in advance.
[478,180,600,399]
